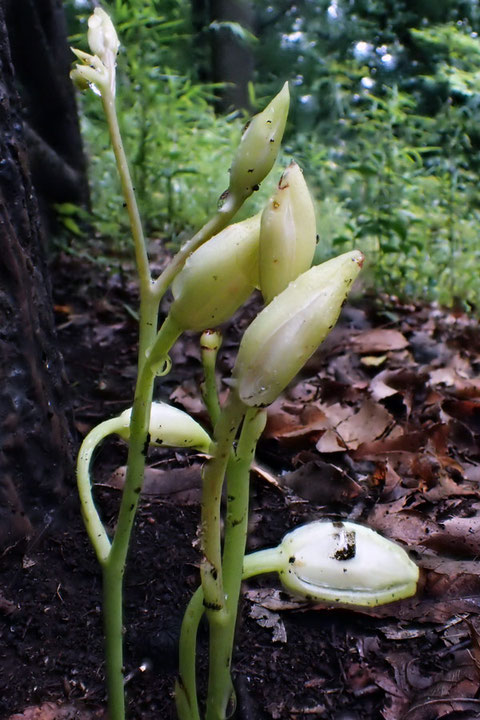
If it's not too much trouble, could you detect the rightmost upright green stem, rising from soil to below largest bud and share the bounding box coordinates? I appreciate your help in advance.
[206,408,266,720]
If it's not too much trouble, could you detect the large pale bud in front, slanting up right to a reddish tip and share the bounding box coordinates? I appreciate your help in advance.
[233,250,364,406]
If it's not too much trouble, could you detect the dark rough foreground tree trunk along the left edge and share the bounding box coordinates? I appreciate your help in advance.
[0,2,73,547]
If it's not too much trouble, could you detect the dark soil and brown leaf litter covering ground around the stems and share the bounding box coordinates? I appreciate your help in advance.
[0,249,480,720]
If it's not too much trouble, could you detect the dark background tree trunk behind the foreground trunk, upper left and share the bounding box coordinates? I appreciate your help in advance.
[4,0,88,229]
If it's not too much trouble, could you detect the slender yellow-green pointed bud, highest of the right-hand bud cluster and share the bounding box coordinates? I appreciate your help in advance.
[228,83,290,204]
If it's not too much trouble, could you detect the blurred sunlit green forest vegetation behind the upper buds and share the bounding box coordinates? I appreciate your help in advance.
[65,0,480,309]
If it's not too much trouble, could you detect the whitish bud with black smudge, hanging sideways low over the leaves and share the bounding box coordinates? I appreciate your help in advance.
[244,521,419,607]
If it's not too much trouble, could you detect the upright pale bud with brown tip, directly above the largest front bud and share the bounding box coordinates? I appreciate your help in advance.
[260,162,316,303]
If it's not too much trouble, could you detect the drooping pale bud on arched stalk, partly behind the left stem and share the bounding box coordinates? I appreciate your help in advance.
[115,402,212,452]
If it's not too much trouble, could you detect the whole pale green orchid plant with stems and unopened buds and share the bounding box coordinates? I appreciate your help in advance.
[72,7,418,720]
